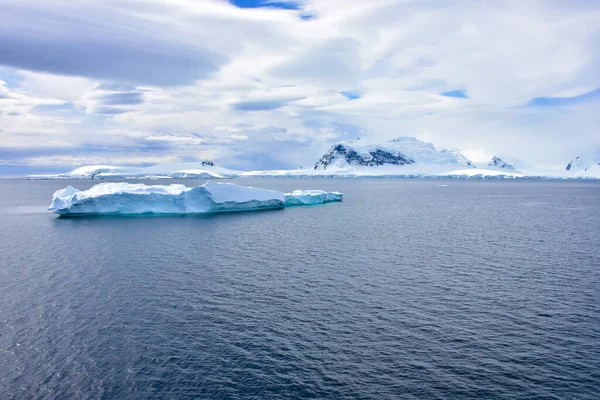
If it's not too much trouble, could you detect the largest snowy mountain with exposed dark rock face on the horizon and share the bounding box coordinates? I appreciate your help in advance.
[314,137,474,170]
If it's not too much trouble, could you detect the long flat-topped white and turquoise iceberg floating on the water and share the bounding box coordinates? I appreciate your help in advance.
[48,181,343,215]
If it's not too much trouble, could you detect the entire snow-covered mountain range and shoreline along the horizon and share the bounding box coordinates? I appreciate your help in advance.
[29,141,600,179]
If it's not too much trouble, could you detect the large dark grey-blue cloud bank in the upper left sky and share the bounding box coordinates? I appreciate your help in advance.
[0,0,227,86]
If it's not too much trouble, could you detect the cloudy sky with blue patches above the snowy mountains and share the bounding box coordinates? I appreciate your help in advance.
[0,0,600,173]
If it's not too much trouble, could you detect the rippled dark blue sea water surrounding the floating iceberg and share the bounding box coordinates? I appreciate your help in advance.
[0,179,600,399]
